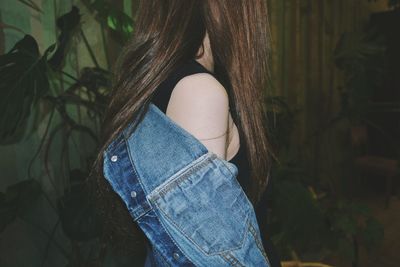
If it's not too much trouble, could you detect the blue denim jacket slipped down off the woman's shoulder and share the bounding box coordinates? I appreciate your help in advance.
[104,103,270,267]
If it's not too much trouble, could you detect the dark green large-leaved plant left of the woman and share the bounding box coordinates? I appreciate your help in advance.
[0,1,128,266]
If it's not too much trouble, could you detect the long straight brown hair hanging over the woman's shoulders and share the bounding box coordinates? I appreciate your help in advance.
[92,0,272,260]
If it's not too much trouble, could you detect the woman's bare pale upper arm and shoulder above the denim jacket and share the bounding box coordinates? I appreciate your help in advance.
[166,73,229,159]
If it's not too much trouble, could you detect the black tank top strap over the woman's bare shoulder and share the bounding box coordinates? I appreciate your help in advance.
[152,59,215,113]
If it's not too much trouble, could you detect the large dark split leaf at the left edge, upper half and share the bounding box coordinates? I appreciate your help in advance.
[0,35,49,145]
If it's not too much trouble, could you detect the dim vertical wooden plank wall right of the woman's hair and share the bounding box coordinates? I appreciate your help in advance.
[268,0,387,181]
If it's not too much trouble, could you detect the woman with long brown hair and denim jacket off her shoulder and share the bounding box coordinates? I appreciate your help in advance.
[90,0,278,266]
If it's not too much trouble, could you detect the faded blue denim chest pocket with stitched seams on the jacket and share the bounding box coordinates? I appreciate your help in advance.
[148,152,252,255]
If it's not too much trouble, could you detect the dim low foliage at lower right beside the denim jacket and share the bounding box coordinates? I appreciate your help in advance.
[265,91,384,266]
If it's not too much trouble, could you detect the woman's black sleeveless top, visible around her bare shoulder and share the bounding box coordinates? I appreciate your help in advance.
[151,59,280,267]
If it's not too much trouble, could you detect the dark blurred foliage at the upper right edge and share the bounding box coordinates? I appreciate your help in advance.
[333,5,400,159]
